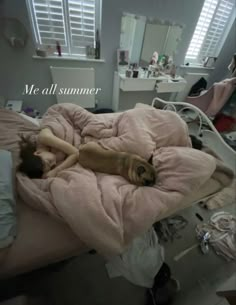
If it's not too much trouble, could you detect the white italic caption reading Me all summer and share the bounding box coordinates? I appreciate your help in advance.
[23,84,102,95]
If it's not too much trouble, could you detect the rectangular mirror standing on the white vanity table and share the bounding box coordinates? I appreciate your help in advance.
[120,13,183,67]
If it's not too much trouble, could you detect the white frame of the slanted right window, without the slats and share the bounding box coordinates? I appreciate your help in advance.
[185,0,236,64]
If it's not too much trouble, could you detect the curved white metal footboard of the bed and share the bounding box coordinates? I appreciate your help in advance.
[152,97,236,174]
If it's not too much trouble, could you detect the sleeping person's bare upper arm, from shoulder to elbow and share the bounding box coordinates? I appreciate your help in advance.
[38,128,78,155]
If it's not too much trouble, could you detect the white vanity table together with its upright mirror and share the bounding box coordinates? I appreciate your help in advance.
[112,12,186,111]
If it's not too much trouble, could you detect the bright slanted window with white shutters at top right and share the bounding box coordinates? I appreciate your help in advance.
[185,0,235,63]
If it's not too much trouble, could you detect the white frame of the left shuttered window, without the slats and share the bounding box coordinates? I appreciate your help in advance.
[26,0,102,59]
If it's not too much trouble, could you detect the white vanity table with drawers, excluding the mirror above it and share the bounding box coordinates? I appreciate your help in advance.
[112,71,186,112]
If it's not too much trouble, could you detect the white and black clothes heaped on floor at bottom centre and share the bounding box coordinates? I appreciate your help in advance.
[106,228,180,305]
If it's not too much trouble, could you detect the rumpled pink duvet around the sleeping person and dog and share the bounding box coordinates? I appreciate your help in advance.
[18,104,216,256]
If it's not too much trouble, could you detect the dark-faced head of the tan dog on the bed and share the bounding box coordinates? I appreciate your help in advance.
[129,156,156,186]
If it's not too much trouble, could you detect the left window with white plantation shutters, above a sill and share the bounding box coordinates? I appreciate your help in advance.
[27,0,101,57]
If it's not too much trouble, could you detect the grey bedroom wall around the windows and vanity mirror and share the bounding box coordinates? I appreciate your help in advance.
[0,0,226,112]
